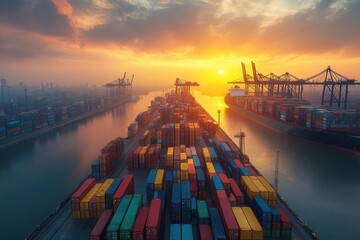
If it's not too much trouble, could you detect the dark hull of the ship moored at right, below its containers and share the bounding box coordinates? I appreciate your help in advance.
[225,98,360,153]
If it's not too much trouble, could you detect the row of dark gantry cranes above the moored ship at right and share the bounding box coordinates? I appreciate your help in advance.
[228,62,360,109]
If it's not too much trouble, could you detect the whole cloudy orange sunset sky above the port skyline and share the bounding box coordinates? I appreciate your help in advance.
[0,0,360,93]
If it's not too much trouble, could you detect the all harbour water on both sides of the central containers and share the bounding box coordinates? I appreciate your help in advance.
[0,92,360,239]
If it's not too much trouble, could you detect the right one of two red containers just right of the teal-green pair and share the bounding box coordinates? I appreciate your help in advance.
[145,198,161,240]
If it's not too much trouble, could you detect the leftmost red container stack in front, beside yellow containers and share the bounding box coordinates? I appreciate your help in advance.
[71,178,96,219]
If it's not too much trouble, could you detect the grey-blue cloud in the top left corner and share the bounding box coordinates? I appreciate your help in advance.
[0,0,73,38]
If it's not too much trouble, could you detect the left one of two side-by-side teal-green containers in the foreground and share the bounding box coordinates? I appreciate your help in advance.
[106,195,132,240]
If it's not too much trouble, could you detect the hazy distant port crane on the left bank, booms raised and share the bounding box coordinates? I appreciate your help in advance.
[104,72,134,99]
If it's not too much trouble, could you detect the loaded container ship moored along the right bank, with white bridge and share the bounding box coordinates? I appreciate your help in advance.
[225,86,360,153]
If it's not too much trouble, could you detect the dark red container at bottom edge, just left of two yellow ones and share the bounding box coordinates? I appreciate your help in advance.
[219,198,239,240]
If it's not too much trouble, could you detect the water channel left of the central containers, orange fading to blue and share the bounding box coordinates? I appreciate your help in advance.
[0,93,154,239]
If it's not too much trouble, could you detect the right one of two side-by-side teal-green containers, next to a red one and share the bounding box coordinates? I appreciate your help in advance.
[120,194,143,239]
